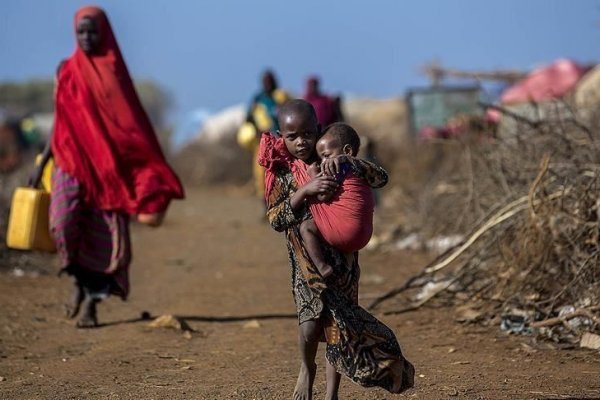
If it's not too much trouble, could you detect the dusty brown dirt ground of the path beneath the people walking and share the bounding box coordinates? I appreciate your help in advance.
[0,186,600,399]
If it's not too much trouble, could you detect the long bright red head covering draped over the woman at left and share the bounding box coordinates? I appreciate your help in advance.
[52,7,183,214]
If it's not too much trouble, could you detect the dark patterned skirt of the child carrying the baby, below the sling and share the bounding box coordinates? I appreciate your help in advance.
[287,228,415,393]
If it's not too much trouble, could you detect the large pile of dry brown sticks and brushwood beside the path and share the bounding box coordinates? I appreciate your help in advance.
[378,104,600,341]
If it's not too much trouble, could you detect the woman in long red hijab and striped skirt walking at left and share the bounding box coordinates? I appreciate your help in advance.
[44,7,183,327]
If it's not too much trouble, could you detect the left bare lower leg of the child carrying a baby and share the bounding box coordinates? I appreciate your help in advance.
[293,320,323,400]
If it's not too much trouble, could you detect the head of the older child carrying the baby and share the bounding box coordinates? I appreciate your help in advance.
[277,99,321,162]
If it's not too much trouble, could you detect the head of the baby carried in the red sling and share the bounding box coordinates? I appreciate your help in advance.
[316,122,360,158]
